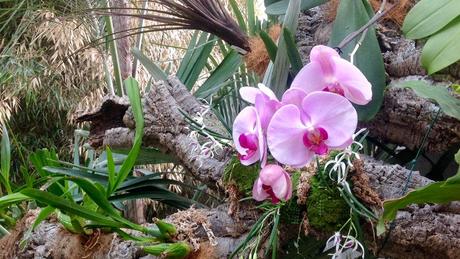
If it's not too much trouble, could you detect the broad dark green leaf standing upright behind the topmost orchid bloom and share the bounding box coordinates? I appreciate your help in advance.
[329,0,386,121]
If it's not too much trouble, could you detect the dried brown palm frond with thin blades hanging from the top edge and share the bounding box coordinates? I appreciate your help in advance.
[91,0,250,53]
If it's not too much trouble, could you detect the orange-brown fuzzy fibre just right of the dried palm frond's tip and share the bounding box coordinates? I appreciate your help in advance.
[244,24,281,77]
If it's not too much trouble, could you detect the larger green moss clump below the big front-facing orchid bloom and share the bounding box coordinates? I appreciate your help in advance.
[307,176,350,232]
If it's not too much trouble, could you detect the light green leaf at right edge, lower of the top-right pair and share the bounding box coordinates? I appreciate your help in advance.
[422,16,460,74]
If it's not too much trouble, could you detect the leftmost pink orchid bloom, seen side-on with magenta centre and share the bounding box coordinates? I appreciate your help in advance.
[233,106,267,165]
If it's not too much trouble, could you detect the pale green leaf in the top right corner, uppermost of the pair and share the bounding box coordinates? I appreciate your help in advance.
[402,0,460,39]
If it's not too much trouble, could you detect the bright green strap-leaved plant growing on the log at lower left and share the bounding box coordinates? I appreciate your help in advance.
[0,79,194,257]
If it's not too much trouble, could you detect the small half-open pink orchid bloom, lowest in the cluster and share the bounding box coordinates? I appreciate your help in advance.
[252,165,292,204]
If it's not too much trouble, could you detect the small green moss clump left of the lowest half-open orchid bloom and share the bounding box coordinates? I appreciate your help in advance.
[224,156,260,194]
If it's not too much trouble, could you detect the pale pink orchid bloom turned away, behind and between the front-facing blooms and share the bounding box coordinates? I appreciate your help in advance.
[240,84,281,132]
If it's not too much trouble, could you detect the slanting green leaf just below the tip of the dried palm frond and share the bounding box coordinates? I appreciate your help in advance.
[195,50,243,99]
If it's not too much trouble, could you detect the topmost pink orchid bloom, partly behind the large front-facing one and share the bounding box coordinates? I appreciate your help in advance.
[291,45,372,105]
